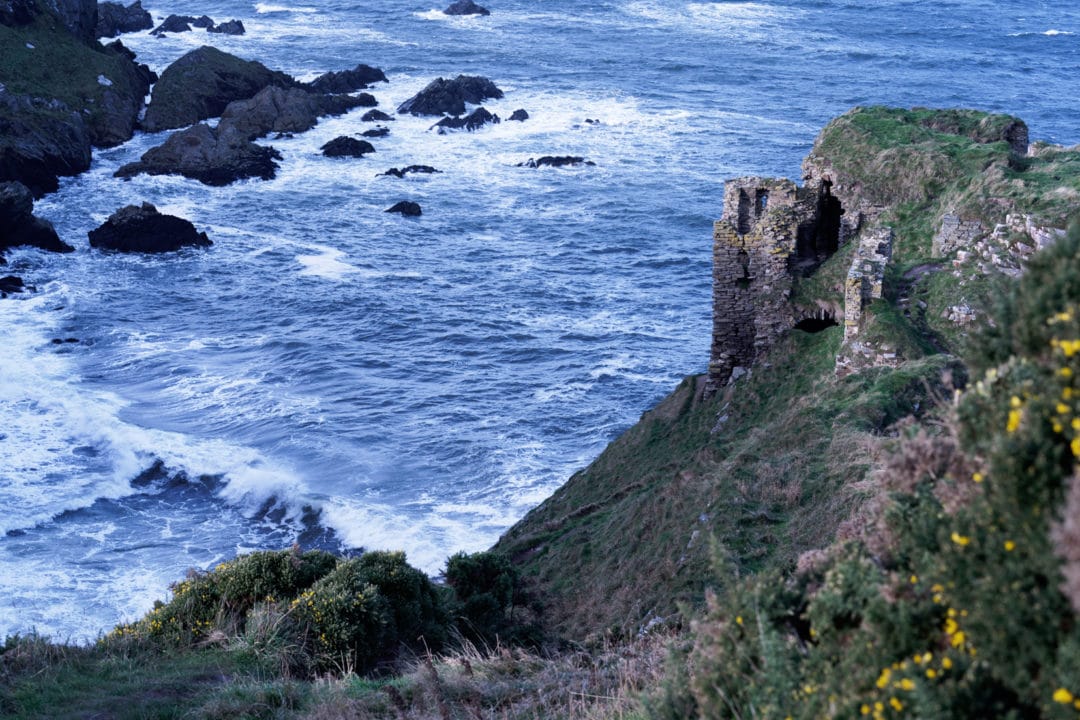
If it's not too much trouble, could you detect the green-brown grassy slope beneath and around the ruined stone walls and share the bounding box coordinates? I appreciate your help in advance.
[497,108,1080,638]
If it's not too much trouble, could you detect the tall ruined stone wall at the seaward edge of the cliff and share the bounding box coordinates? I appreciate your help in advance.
[705,177,800,394]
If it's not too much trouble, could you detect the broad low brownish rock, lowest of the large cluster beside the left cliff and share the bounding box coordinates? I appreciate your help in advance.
[116,123,281,186]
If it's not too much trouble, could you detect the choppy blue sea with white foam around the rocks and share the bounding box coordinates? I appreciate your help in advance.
[0,0,1080,640]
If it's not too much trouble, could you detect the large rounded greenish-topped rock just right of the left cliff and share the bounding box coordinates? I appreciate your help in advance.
[143,46,297,133]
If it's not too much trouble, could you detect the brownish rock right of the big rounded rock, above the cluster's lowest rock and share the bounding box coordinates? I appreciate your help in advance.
[218,85,365,140]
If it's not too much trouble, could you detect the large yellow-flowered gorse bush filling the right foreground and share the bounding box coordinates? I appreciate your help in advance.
[654,222,1080,719]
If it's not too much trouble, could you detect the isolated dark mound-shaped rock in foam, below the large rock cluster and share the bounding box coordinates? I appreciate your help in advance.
[89,203,213,253]
